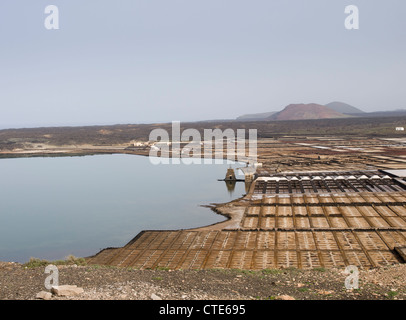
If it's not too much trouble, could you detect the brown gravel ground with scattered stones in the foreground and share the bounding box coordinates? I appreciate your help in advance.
[0,262,406,300]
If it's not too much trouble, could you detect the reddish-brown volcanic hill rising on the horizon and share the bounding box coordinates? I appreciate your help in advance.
[268,103,348,120]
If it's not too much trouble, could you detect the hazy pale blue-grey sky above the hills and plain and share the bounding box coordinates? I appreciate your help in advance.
[0,0,406,128]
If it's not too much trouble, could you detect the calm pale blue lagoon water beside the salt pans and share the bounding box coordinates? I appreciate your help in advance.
[0,155,245,262]
